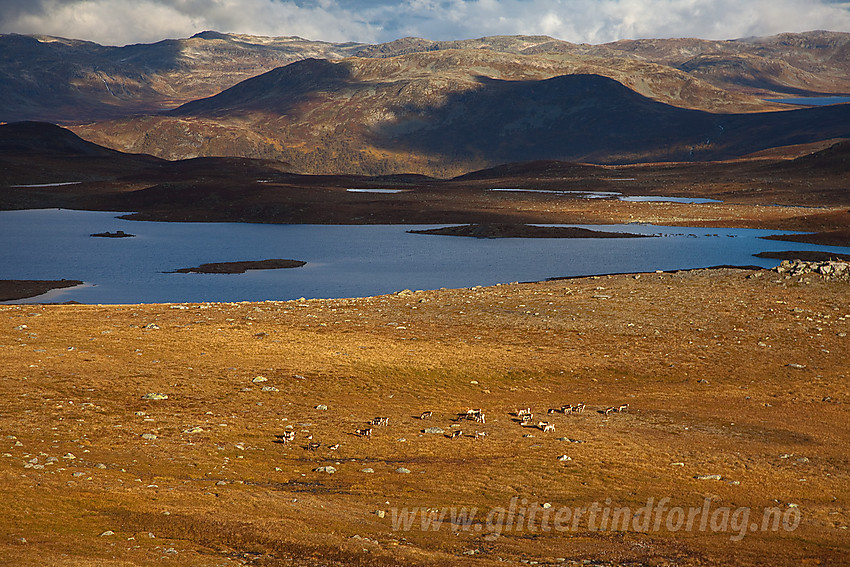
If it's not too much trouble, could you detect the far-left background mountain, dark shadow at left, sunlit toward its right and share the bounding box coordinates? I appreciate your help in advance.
[0,32,359,123]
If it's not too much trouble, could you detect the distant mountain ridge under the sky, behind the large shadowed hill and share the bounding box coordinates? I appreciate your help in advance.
[0,31,850,123]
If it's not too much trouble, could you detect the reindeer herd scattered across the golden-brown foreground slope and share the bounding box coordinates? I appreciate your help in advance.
[275,402,629,451]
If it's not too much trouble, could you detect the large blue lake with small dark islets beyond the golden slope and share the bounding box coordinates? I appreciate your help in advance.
[0,209,850,303]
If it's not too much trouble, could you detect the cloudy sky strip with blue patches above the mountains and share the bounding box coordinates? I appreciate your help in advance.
[0,0,850,45]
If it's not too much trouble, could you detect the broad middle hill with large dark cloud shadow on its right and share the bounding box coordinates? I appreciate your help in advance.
[76,54,850,177]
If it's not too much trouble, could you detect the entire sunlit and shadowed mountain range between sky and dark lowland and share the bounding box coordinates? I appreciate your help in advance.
[0,28,850,177]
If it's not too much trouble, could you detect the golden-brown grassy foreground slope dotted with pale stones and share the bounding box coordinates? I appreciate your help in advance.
[0,270,850,565]
